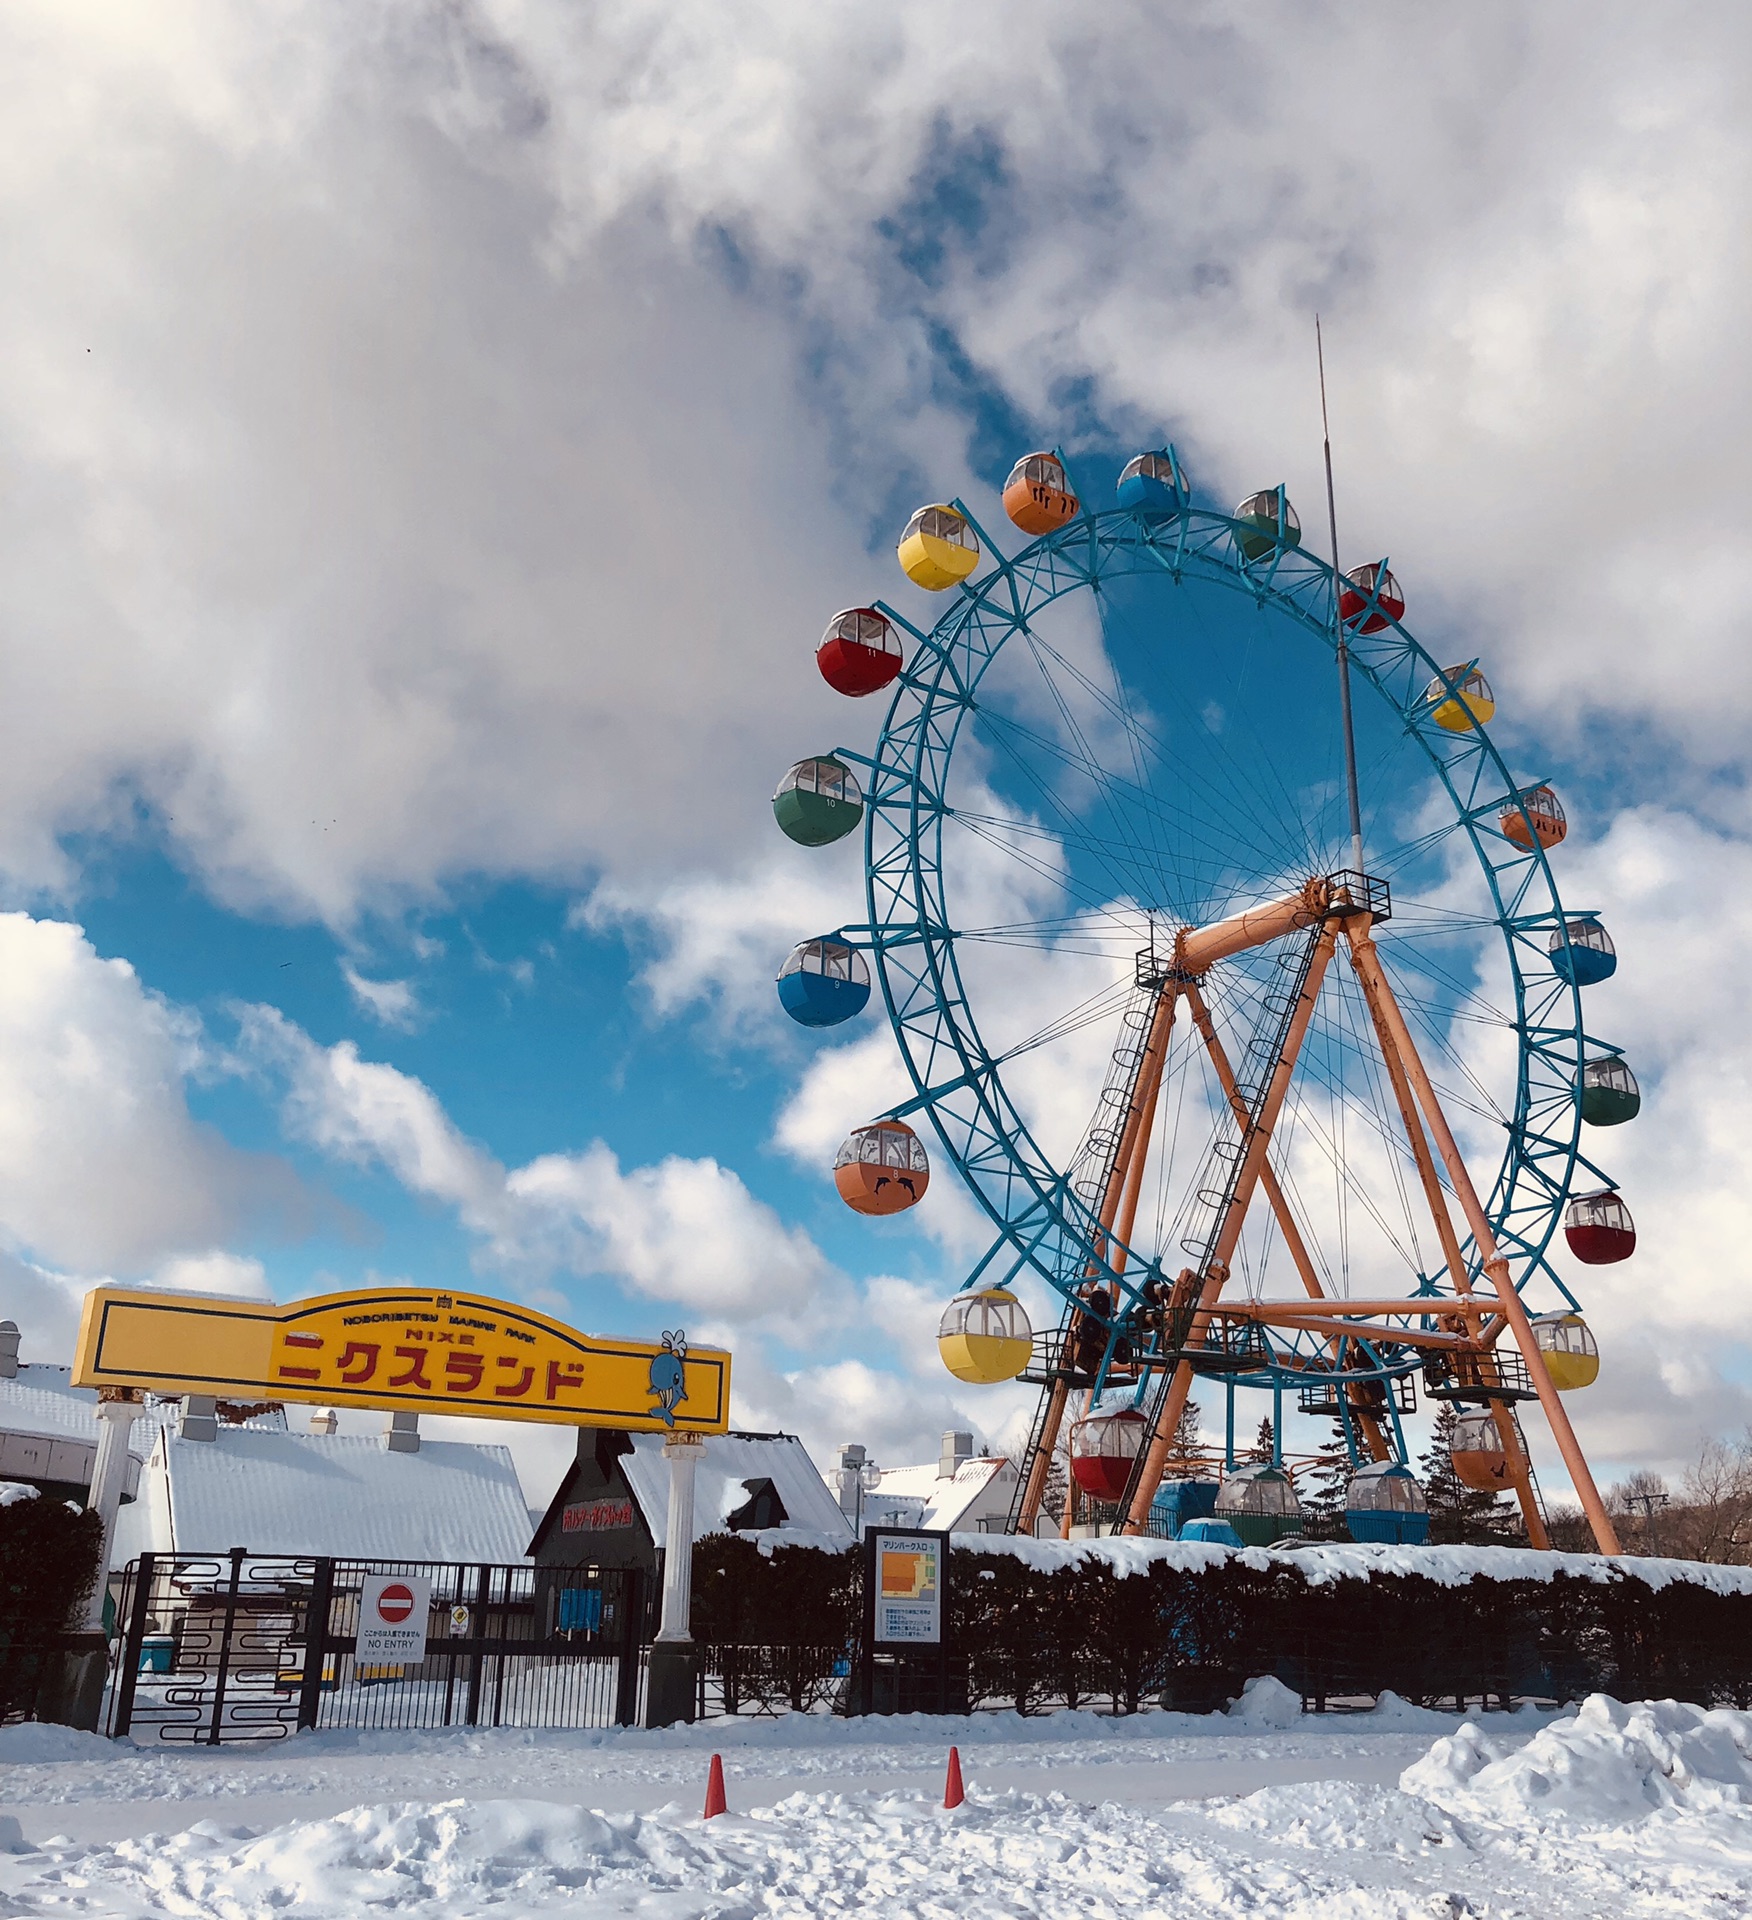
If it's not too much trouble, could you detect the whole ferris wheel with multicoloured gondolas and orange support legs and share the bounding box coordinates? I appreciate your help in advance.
[773,447,1641,1553]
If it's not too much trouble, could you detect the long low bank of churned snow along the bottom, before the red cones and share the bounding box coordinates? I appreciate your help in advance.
[68,1791,1420,1920]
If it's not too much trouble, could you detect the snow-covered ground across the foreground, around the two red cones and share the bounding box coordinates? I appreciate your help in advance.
[0,1680,1752,1920]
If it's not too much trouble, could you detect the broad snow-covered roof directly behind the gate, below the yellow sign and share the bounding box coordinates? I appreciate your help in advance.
[115,1427,530,1563]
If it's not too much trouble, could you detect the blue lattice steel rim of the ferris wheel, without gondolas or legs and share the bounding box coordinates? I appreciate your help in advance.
[835,466,1618,1394]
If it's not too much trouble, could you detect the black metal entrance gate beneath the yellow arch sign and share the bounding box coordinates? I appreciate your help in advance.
[104,1548,645,1745]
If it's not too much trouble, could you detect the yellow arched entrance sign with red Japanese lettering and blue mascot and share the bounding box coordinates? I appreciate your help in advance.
[73,1286,729,1434]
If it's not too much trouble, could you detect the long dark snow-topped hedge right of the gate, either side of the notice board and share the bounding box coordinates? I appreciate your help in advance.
[695,1536,1752,1713]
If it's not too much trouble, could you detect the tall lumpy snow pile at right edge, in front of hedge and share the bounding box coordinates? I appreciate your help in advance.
[1399,1693,1752,1826]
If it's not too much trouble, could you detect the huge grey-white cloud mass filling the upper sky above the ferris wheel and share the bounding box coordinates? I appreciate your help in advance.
[0,0,1752,936]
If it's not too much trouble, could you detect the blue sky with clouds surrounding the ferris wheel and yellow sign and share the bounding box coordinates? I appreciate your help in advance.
[0,0,1752,1501]
